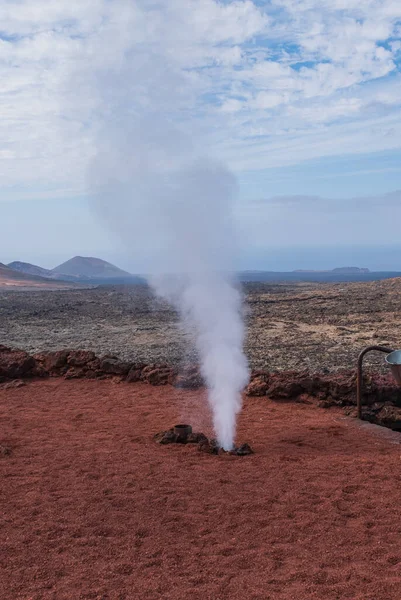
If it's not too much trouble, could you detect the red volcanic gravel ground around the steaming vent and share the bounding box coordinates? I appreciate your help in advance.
[0,379,401,600]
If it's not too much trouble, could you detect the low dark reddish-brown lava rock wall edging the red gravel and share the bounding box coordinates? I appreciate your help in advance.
[0,345,401,430]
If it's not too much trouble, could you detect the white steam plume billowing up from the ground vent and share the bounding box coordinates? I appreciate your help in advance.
[91,118,248,449]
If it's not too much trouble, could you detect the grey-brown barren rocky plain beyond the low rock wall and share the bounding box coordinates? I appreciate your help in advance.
[0,279,401,372]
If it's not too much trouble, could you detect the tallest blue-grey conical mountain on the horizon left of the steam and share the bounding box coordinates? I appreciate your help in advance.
[51,256,134,281]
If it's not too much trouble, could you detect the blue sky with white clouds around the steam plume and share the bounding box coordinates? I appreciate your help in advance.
[0,0,401,272]
